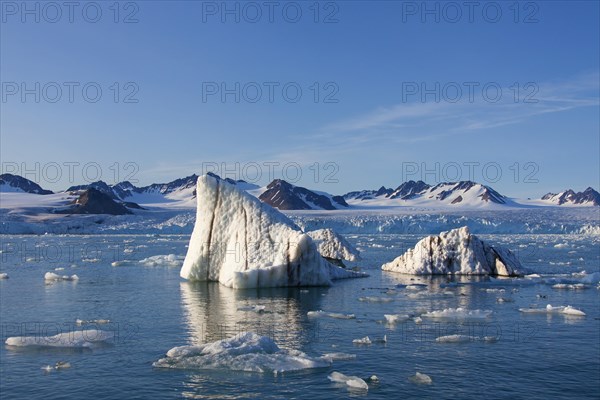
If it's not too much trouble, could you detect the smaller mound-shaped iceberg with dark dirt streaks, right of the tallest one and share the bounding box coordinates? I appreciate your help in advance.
[381,226,523,276]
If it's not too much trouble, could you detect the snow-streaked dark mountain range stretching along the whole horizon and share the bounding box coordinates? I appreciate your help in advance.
[0,173,600,210]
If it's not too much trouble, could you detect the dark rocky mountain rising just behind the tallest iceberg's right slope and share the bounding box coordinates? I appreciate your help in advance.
[258,179,348,210]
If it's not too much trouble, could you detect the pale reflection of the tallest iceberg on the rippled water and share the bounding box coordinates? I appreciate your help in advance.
[180,282,328,349]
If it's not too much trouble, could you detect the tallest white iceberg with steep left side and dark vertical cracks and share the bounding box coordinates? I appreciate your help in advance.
[180,175,359,288]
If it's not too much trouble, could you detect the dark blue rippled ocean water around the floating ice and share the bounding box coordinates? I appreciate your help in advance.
[0,234,600,400]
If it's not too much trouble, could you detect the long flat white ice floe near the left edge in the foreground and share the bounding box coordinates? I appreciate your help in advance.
[5,329,114,348]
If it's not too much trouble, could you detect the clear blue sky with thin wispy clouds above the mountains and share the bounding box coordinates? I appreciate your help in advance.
[0,1,600,197]
